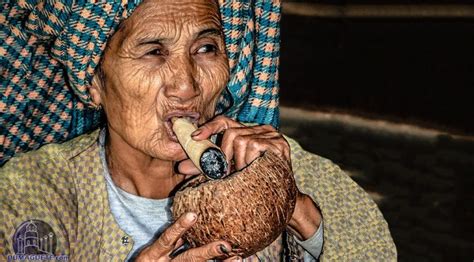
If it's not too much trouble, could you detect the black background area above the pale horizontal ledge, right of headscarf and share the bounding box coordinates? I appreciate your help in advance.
[281,0,474,134]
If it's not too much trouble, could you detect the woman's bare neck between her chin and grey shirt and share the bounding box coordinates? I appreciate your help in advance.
[105,128,185,199]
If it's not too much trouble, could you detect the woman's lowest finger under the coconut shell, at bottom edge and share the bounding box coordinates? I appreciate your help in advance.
[173,241,231,261]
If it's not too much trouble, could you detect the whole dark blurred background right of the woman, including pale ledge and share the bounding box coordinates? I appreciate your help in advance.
[280,0,474,261]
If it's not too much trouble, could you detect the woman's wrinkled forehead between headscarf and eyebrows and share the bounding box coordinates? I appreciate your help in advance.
[104,0,224,62]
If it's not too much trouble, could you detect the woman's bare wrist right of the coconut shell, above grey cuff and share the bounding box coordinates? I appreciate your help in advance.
[288,193,322,241]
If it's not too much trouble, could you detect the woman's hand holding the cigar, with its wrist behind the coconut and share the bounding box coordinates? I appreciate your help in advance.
[178,116,322,240]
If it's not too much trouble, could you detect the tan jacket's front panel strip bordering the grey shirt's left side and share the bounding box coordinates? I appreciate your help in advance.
[62,129,133,260]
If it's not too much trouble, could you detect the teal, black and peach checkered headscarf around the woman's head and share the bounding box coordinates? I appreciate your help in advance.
[0,0,280,165]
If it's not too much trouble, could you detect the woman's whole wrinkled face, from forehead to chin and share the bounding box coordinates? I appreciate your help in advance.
[94,0,229,160]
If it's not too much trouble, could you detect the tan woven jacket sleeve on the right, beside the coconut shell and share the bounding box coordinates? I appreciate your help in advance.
[287,138,397,261]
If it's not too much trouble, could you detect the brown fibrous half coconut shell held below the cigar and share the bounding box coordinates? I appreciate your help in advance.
[172,152,297,258]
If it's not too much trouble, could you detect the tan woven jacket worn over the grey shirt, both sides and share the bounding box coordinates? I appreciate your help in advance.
[0,131,397,261]
